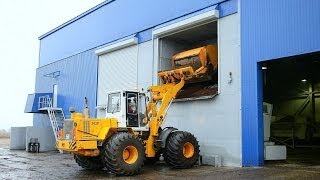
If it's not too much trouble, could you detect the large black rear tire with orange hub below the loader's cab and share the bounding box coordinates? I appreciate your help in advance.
[103,132,145,176]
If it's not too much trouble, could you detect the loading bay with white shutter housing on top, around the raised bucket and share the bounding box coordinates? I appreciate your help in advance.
[153,10,219,100]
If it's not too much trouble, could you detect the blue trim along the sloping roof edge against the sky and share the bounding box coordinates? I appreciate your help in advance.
[38,0,115,40]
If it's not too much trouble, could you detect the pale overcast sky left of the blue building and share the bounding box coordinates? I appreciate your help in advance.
[0,0,103,129]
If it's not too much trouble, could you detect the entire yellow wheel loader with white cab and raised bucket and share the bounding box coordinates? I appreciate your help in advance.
[56,45,217,175]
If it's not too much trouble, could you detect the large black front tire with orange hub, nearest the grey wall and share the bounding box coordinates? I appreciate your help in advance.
[163,131,200,169]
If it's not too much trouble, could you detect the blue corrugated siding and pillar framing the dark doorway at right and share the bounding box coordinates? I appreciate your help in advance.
[240,0,320,166]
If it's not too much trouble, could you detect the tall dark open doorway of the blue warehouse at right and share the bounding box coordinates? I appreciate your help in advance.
[260,52,320,165]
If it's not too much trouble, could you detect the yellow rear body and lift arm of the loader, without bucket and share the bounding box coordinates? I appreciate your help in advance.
[56,79,185,157]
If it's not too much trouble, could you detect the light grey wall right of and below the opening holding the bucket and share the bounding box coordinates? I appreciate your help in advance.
[164,13,242,166]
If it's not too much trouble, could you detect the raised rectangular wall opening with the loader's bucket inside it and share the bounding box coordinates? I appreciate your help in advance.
[159,21,218,100]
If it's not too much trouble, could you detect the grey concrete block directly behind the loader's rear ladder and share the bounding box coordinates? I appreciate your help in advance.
[25,127,56,152]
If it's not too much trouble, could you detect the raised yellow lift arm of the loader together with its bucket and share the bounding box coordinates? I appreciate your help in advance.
[146,45,218,157]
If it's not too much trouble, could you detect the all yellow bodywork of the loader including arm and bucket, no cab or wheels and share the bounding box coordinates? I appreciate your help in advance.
[56,45,218,157]
